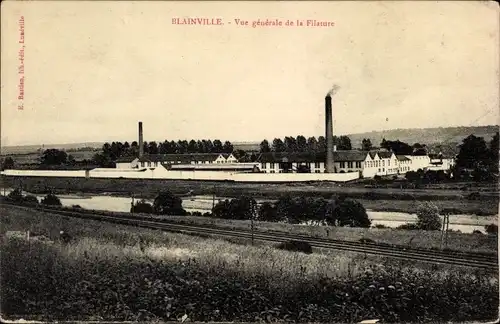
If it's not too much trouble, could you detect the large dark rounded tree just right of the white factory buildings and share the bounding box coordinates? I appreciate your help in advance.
[456,135,490,169]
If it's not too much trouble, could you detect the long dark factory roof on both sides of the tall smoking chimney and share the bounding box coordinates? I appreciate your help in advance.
[258,151,366,163]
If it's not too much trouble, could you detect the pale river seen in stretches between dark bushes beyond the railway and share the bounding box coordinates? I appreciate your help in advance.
[2,189,498,233]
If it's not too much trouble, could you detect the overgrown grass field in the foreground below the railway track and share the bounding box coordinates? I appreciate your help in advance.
[0,206,498,323]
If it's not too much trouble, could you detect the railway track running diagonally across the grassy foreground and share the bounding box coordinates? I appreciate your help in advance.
[3,203,498,272]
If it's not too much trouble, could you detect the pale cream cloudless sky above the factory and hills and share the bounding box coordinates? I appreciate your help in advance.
[0,1,500,146]
